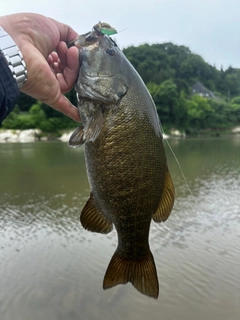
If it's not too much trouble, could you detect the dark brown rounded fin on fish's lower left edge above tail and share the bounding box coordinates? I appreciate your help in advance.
[80,194,113,233]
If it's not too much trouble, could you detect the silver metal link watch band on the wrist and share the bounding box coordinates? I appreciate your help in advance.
[0,26,27,89]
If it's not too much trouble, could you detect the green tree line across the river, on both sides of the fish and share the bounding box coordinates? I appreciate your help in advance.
[2,43,240,134]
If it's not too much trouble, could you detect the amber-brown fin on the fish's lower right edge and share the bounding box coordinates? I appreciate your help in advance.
[153,169,175,222]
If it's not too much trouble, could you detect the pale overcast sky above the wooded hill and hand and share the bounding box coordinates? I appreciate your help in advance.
[0,0,240,69]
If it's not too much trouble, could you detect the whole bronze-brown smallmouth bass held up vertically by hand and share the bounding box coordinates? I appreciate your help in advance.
[68,25,175,299]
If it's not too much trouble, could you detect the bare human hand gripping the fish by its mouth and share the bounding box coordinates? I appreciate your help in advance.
[0,13,80,121]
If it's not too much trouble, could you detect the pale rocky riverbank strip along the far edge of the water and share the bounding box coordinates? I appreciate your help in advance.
[0,127,240,143]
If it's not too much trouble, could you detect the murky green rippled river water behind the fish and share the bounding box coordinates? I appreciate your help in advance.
[0,136,240,320]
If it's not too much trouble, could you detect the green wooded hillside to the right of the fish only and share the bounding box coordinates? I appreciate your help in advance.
[124,43,240,132]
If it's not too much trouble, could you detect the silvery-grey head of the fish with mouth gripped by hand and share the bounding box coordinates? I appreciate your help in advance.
[75,31,128,106]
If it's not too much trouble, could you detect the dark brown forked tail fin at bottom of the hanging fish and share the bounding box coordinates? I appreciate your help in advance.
[103,250,159,299]
